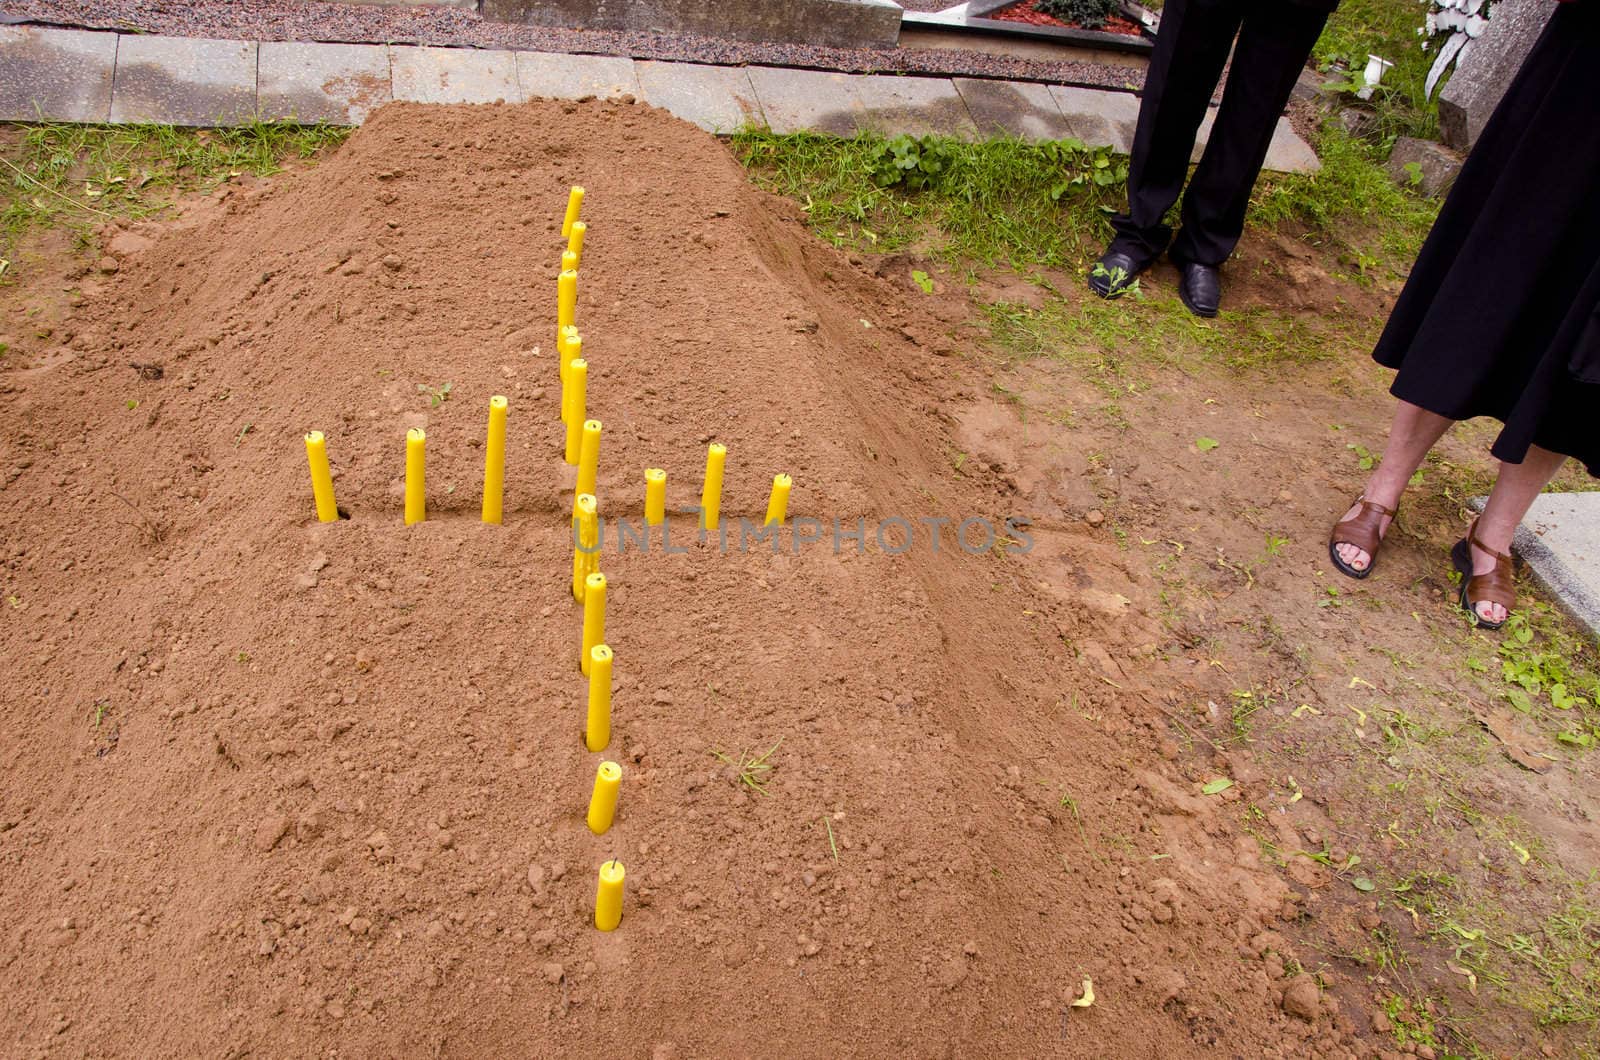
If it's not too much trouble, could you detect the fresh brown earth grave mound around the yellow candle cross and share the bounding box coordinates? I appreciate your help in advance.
[0,102,1347,1057]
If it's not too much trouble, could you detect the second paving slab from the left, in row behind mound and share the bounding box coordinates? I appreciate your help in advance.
[110,34,256,125]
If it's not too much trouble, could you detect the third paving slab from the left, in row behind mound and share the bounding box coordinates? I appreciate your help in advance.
[256,40,392,125]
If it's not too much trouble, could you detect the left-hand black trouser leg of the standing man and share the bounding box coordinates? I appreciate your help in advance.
[1109,0,1246,269]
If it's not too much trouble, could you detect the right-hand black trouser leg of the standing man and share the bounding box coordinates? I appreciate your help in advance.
[1171,0,1328,266]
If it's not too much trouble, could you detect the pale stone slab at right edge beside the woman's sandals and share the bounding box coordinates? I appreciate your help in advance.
[1470,493,1600,637]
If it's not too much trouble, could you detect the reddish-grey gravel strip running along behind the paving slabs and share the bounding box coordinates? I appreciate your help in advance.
[0,0,1142,88]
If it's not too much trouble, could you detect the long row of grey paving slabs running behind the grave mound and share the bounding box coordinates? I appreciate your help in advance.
[0,26,1320,173]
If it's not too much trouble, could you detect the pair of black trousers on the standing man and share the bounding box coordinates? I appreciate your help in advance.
[1110,0,1328,266]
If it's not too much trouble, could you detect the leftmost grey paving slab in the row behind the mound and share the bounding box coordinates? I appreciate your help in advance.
[0,26,117,122]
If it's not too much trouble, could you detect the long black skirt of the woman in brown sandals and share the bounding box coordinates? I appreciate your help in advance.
[1373,0,1600,476]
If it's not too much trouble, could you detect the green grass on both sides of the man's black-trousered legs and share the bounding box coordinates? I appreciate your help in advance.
[731,125,1438,275]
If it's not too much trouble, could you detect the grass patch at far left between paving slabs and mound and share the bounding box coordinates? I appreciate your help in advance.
[0,122,352,256]
